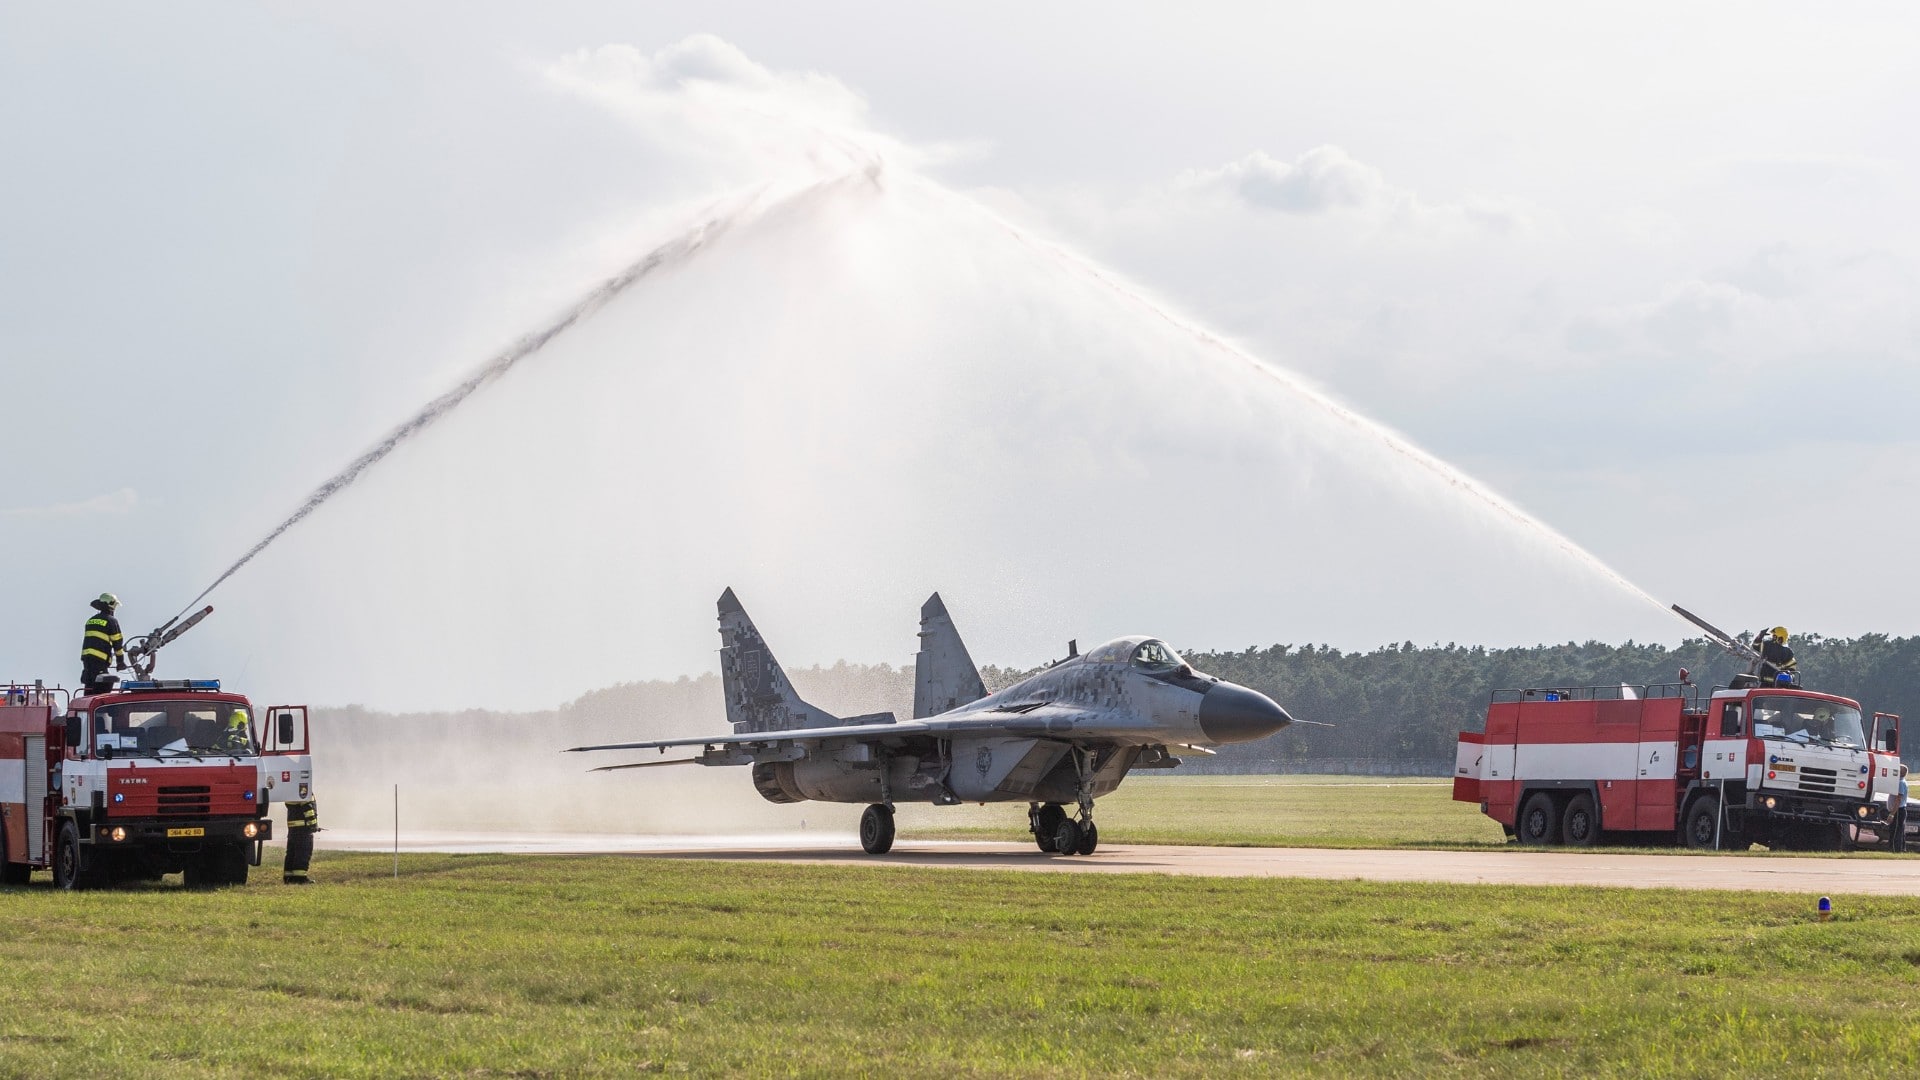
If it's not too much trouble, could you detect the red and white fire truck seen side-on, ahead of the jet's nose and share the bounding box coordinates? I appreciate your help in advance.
[1453,675,1907,851]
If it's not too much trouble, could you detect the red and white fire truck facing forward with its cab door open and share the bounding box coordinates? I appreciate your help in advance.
[0,678,313,890]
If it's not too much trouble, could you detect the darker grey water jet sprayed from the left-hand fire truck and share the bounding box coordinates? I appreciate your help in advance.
[180,184,779,615]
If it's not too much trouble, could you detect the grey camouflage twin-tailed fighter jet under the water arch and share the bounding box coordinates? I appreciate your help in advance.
[572,588,1294,855]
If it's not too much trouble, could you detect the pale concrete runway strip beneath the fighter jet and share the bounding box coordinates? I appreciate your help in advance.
[319,830,1920,896]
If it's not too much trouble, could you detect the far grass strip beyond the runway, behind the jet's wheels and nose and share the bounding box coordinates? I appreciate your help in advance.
[890,774,1507,847]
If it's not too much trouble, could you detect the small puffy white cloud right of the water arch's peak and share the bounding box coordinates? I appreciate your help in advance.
[1173,146,1530,233]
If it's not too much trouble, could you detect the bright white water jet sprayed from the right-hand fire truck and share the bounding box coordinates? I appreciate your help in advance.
[913,181,1670,615]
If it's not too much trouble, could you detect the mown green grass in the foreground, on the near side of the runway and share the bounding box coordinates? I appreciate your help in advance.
[0,853,1920,1076]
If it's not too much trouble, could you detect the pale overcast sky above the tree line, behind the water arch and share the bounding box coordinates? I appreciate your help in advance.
[0,2,1920,707]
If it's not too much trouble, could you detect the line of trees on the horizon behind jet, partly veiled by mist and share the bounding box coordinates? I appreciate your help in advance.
[315,634,1920,774]
